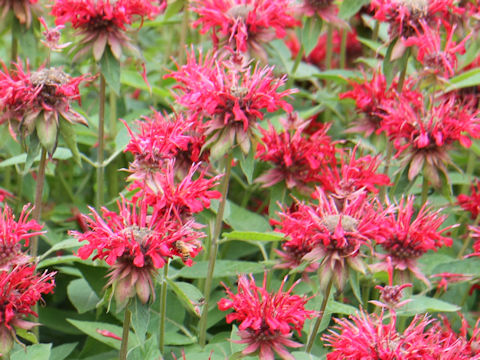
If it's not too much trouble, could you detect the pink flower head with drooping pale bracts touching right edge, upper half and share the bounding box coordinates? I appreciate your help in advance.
[382,96,480,187]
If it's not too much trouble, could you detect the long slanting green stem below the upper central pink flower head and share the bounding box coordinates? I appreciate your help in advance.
[199,154,232,347]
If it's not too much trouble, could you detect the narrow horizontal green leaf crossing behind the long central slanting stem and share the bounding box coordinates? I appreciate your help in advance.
[176,260,265,279]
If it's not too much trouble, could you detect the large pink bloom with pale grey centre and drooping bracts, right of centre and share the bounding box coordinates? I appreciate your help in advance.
[272,188,383,290]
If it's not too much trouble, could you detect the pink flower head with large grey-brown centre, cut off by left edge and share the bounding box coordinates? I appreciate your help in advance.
[0,63,88,153]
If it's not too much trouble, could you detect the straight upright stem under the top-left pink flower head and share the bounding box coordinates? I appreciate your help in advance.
[95,74,106,209]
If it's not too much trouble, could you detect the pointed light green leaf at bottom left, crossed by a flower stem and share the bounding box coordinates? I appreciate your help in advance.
[67,319,138,350]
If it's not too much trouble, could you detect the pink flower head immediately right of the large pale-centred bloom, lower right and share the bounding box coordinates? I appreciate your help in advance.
[371,196,455,285]
